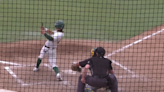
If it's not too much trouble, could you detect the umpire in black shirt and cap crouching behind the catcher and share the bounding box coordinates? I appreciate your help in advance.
[77,47,118,92]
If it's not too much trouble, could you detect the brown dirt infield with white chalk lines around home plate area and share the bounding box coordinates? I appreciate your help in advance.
[0,25,164,92]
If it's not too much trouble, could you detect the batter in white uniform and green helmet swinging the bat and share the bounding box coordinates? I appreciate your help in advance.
[33,20,64,81]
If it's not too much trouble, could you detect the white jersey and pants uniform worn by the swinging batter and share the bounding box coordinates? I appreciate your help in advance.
[39,31,64,67]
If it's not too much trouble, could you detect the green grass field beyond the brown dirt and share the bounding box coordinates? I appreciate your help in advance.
[0,0,164,42]
